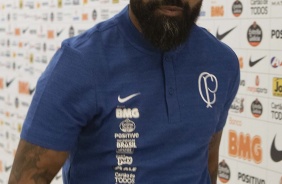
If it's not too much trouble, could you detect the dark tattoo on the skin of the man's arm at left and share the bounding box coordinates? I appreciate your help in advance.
[11,143,52,184]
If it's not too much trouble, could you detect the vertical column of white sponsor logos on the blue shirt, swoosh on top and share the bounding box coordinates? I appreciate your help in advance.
[113,93,141,184]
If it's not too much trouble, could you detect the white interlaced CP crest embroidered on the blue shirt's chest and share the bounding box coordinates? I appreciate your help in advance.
[198,72,218,108]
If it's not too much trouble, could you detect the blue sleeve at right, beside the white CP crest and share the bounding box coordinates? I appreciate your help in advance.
[216,54,240,132]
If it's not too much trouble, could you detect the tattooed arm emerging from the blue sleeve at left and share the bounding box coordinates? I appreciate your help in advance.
[9,140,68,184]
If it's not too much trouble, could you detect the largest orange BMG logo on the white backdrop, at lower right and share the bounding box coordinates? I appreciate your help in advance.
[228,130,262,164]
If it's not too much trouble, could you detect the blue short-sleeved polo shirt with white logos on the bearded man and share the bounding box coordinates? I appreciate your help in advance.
[21,7,239,184]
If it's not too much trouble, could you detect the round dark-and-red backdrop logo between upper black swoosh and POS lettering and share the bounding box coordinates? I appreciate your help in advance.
[247,22,263,47]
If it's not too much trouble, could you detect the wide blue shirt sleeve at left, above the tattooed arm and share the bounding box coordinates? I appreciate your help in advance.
[21,44,96,151]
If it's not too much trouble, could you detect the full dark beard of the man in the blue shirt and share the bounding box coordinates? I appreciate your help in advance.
[130,0,202,52]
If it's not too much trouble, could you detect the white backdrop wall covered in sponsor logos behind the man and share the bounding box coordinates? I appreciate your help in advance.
[0,0,282,184]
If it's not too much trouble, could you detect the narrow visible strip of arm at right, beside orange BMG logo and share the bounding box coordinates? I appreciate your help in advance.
[209,131,222,184]
